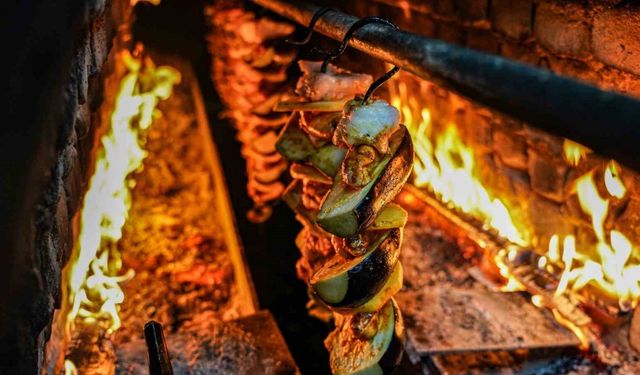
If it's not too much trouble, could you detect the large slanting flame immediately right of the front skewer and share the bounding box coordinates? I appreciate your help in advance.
[390,80,527,246]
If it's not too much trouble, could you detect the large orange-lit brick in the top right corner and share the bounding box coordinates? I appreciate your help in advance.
[592,9,640,74]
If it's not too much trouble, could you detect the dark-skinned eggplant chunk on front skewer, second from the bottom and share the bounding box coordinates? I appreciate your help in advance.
[310,228,402,310]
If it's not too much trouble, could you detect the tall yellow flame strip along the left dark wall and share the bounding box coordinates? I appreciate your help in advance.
[65,51,180,334]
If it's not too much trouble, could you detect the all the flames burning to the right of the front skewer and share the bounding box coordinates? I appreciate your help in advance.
[389,75,640,330]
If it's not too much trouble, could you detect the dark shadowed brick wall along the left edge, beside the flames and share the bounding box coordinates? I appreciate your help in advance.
[0,0,128,374]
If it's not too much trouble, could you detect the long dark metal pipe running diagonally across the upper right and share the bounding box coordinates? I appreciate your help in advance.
[254,0,640,170]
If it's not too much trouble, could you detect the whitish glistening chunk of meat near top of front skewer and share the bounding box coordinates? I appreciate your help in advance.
[333,99,400,154]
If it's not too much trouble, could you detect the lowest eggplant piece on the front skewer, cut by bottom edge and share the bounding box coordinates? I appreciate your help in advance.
[325,299,404,375]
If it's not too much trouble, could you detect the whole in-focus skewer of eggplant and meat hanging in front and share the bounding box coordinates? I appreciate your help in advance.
[276,62,413,374]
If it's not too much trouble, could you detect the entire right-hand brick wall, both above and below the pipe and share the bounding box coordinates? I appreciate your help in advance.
[332,0,640,251]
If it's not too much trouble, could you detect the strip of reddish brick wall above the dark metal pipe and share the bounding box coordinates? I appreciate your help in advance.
[358,0,640,96]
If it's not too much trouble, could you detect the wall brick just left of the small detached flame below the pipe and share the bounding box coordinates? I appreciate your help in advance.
[527,148,568,203]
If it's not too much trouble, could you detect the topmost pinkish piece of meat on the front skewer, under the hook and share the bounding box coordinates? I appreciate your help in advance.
[296,61,373,101]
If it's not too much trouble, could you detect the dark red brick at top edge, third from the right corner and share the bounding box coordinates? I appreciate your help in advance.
[491,0,533,39]
